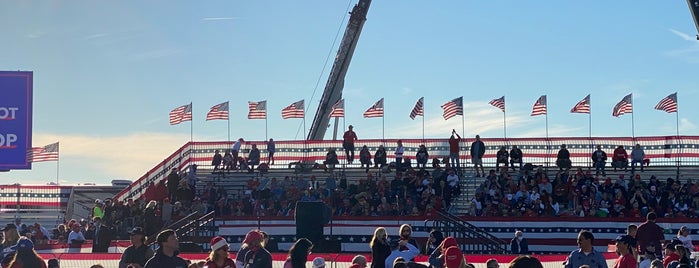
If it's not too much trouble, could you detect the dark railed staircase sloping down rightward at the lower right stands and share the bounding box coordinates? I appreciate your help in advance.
[433,211,507,254]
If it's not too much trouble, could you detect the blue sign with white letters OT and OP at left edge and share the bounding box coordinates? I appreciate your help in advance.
[0,71,33,170]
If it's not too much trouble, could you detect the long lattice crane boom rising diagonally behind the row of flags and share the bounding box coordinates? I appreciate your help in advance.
[307,0,371,140]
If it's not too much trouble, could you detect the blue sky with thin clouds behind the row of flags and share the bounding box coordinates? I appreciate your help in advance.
[0,0,699,183]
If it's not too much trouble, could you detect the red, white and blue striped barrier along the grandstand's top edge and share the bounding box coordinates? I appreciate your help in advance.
[117,136,699,202]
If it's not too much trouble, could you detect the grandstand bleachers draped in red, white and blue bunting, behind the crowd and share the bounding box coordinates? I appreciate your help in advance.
[101,136,699,253]
